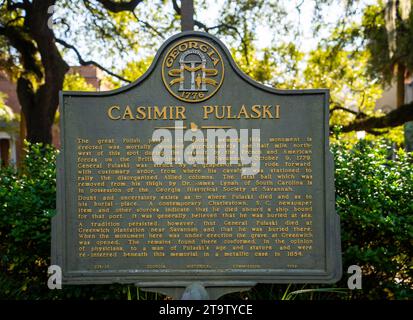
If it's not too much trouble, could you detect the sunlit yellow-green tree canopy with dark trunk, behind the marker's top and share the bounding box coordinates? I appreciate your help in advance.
[0,0,413,142]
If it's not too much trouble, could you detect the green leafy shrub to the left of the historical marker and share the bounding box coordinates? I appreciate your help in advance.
[0,144,126,300]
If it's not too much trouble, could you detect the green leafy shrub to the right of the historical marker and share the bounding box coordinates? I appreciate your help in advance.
[333,140,413,299]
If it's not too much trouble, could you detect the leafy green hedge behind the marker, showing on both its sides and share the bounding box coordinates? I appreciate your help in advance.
[0,141,413,299]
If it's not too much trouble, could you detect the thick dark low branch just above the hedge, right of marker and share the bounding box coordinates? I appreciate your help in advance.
[334,102,413,132]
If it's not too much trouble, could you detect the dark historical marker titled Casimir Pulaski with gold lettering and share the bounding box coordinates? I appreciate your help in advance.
[52,32,341,296]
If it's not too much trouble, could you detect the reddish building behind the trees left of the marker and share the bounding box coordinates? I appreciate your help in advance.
[0,66,112,166]
